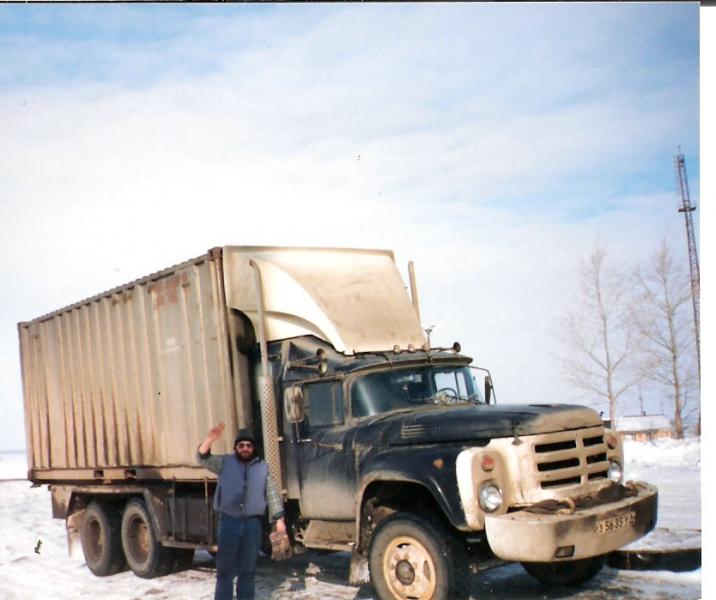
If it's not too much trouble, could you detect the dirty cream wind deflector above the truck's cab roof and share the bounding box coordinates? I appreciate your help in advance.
[223,246,425,354]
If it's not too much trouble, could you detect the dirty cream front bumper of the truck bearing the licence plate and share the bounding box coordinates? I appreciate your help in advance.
[485,482,658,562]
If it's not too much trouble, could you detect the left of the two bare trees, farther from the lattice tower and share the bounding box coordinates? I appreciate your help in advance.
[562,245,640,424]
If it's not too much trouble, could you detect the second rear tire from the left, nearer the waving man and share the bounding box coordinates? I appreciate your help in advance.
[122,498,174,579]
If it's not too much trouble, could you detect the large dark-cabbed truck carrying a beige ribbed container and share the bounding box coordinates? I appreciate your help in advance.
[18,246,658,600]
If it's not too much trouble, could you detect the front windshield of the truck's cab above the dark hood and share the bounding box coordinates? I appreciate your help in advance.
[351,367,483,417]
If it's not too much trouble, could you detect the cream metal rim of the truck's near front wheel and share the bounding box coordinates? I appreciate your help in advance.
[383,536,436,600]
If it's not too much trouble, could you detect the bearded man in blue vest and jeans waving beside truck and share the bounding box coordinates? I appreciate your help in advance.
[197,423,286,600]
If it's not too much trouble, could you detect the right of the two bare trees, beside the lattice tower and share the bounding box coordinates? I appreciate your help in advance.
[631,241,697,438]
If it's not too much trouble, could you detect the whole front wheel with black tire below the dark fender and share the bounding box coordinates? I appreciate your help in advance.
[368,513,469,600]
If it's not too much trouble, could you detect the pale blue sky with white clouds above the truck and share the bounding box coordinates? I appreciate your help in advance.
[0,3,700,449]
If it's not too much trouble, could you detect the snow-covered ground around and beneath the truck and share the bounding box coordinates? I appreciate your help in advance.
[0,440,702,600]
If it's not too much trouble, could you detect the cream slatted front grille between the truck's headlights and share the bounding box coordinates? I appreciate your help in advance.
[534,429,609,489]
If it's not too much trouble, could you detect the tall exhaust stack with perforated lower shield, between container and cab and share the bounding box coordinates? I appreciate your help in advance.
[249,260,284,490]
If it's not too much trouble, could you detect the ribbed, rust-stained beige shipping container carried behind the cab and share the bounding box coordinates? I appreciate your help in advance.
[19,251,243,481]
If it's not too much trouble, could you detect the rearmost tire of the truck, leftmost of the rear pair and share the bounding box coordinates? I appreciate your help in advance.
[80,502,127,577]
